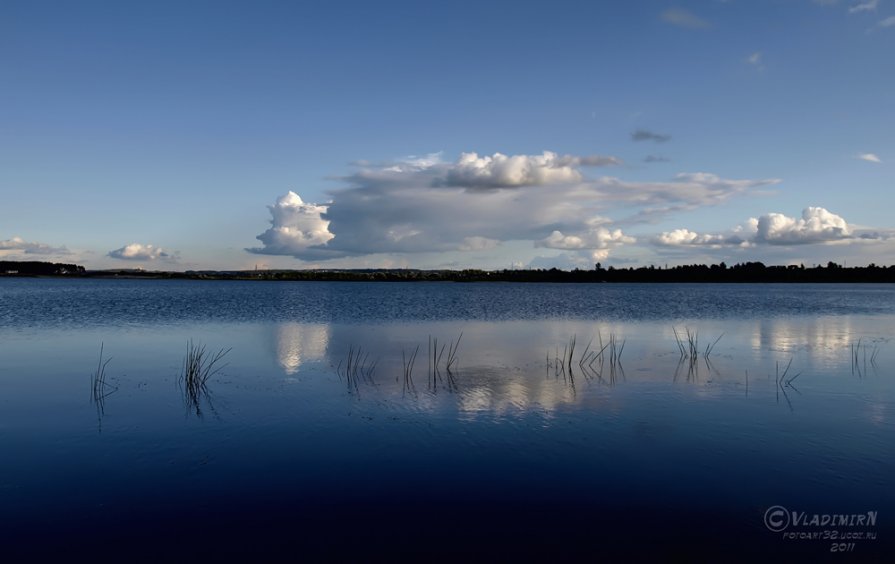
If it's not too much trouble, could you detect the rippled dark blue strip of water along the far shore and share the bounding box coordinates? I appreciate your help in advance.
[0,279,895,327]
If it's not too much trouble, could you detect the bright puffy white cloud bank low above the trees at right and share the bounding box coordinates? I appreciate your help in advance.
[653,207,882,247]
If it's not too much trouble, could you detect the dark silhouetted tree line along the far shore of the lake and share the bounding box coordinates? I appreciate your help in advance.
[0,261,895,283]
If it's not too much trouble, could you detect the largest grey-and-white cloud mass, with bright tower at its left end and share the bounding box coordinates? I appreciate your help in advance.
[247,152,776,261]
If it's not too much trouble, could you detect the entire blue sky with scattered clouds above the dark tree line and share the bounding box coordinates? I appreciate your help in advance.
[0,0,895,270]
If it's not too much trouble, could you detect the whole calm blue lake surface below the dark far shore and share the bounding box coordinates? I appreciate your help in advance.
[0,279,895,561]
